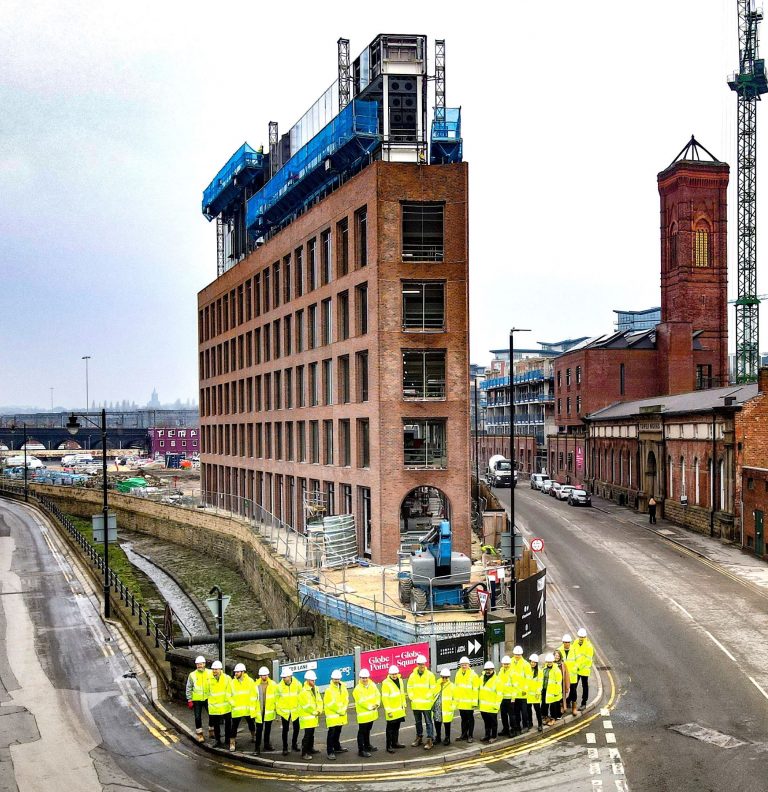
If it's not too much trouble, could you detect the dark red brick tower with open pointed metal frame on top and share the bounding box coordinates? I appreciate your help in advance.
[658,137,729,393]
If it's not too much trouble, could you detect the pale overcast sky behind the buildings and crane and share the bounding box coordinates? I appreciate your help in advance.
[0,0,756,408]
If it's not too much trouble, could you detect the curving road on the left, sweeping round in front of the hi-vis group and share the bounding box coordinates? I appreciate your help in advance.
[0,499,625,792]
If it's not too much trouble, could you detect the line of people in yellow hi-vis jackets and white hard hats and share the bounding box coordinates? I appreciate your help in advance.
[186,628,594,761]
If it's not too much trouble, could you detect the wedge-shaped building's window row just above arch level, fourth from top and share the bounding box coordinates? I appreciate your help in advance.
[201,418,448,470]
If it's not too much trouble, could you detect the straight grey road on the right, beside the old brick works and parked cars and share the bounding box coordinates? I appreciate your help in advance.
[496,482,768,792]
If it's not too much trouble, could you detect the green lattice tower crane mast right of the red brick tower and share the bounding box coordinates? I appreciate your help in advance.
[728,0,768,382]
